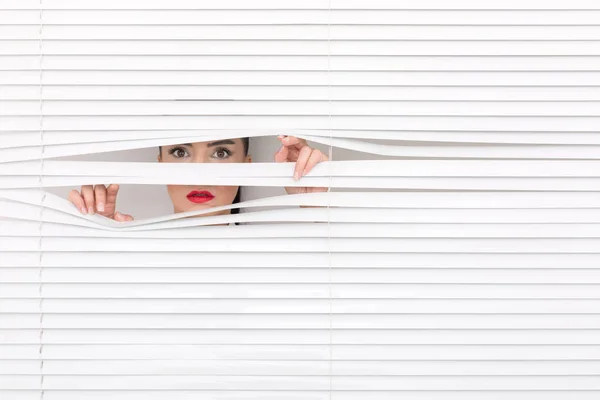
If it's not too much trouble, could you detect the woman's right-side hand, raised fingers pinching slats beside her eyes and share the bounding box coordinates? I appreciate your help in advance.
[275,135,329,194]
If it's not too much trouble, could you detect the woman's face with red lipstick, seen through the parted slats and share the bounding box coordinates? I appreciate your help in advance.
[158,139,252,216]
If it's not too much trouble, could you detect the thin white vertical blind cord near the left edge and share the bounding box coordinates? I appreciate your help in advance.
[38,0,46,399]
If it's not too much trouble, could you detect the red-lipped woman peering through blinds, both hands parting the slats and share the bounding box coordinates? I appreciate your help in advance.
[69,135,328,222]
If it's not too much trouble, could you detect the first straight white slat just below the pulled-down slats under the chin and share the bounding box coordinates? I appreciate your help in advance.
[8,220,600,239]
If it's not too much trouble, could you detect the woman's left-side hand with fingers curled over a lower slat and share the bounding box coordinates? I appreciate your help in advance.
[69,184,133,222]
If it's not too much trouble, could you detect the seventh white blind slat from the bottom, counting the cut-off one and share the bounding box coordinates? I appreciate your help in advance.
[5,296,600,312]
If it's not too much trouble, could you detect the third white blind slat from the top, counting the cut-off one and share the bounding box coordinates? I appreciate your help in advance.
[8,24,600,41]
